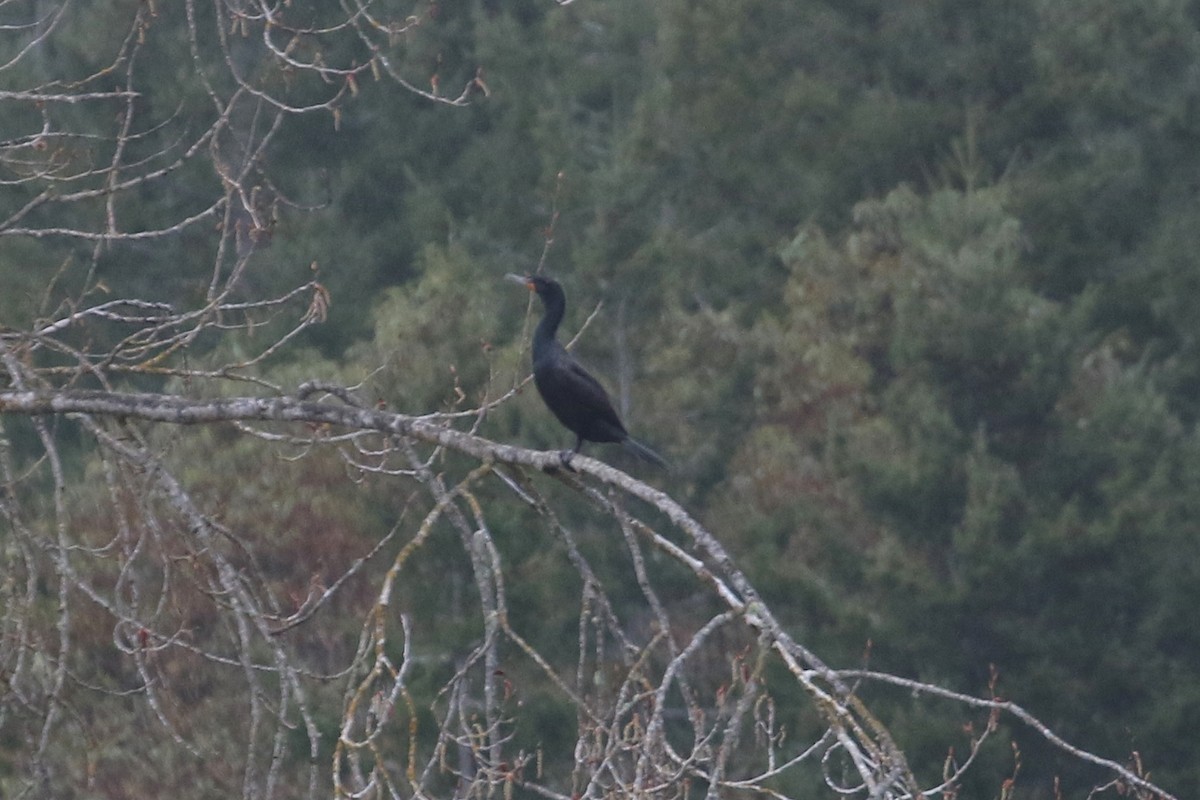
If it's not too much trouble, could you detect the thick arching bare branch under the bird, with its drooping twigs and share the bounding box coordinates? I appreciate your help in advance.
[0,387,1172,799]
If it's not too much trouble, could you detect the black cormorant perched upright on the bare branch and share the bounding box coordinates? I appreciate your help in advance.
[506,275,667,468]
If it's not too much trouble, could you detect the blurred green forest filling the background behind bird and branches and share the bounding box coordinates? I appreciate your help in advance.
[0,0,1200,798]
